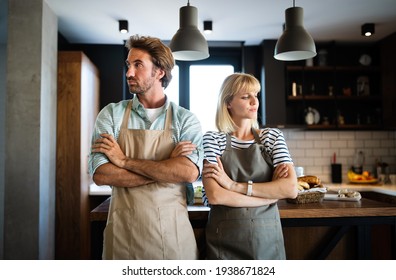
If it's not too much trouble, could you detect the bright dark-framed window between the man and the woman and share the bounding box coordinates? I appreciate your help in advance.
[165,48,242,133]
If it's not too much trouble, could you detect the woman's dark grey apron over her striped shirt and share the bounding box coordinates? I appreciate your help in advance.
[206,129,286,260]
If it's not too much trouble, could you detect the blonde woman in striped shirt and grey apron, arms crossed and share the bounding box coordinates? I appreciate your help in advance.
[202,73,297,259]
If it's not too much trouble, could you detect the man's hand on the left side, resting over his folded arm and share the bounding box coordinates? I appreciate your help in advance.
[92,133,126,168]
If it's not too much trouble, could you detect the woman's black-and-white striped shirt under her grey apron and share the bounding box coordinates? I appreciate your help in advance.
[202,128,293,205]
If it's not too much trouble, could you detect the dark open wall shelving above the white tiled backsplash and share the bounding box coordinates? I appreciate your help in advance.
[285,43,383,130]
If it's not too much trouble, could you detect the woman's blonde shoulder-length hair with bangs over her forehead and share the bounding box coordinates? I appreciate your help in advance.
[216,73,261,133]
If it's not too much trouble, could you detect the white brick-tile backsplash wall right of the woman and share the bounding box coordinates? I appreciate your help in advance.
[282,129,396,182]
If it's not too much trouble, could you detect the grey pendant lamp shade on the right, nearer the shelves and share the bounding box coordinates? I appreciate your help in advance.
[274,7,316,61]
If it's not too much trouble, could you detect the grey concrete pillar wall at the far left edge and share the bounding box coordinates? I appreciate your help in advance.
[2,0,58,259]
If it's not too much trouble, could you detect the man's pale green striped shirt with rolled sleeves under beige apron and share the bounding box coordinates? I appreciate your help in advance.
[88,95,203,175]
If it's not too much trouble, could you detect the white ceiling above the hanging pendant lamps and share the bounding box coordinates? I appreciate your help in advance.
[46,0,396,45]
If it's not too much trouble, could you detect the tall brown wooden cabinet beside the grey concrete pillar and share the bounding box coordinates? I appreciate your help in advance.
[55,51,99,259]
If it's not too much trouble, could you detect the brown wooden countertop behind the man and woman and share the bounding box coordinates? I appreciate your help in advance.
[90,192,396,221]
